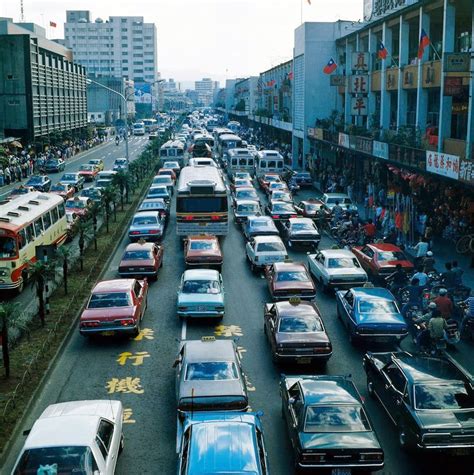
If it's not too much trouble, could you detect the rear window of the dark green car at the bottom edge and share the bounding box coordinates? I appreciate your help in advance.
[304,405,370,432]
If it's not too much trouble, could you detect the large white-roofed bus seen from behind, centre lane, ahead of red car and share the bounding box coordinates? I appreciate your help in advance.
[176,165,229,236]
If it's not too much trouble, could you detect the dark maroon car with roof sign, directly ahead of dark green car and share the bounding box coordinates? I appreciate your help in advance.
[263,298,332,365]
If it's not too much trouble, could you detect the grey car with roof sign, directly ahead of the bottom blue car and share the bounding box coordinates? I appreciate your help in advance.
[174,337,249,419]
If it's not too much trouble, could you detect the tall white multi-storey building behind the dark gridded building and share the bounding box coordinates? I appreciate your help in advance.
[64,11,159,116]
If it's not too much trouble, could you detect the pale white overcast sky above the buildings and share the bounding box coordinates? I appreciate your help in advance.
[0,0,363,83]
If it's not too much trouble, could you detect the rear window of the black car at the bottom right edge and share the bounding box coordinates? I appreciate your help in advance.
[415,381,474,410]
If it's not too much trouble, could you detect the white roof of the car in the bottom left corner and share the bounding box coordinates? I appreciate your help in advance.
[25,400,122,449]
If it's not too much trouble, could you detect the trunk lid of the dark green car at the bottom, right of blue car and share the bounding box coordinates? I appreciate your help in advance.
[299,432,381,450]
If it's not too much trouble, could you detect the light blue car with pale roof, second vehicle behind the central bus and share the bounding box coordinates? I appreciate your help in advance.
[177,269,225,318]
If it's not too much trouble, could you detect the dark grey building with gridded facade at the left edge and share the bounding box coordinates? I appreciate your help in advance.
[0,18,87,141]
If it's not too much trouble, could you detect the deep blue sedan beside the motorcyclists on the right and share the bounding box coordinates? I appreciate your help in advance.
[336,287,408,343]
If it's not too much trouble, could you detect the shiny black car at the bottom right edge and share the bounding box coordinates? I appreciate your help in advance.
[363,352,474,455]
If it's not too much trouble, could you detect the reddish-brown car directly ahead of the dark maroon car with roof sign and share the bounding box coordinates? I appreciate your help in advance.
[265,262,316,300]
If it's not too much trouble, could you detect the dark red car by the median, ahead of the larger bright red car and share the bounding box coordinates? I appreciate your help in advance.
[118,239,163,280]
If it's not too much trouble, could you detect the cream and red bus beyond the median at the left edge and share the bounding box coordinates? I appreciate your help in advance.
[0,192,67,293]
